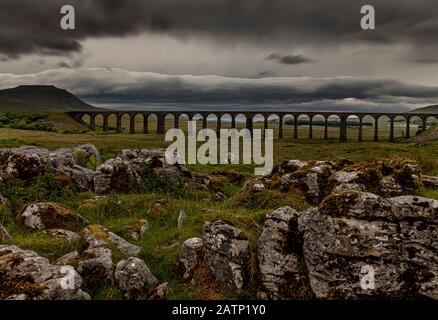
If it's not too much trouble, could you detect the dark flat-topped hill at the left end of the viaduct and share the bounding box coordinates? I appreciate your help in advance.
[0,85,100,112]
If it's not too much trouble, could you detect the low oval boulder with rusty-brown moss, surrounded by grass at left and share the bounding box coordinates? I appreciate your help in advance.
[16,202,88,230]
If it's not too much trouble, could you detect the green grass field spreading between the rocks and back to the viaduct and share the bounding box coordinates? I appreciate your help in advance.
[0,111,438,299]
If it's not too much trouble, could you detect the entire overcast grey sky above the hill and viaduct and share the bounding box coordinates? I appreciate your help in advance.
[0,0,438,111]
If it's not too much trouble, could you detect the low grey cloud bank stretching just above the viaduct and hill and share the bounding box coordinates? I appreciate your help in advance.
[0,68,438,111]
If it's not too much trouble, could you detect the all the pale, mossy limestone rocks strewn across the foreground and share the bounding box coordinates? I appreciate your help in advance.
[0,145,438,299]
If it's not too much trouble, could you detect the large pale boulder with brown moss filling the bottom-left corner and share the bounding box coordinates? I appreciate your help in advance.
[0,245,90,300]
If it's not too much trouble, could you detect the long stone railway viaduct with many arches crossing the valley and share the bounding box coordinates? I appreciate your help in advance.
[69,111,438,142]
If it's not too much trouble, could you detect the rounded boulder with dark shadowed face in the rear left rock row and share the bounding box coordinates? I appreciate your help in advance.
[94,158,141,195]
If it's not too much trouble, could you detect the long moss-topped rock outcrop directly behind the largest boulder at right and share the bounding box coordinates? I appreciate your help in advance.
[236,159,424,205]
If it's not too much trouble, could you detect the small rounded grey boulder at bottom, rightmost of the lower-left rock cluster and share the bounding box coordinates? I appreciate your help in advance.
[114,257,159,300]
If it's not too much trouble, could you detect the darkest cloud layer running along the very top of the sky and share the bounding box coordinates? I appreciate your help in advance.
[0,0,438,57]
